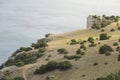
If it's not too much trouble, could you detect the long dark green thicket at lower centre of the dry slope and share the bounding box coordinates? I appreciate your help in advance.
[34,61,72,74]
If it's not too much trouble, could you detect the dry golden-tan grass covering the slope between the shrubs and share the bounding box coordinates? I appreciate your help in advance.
[1,23,120,80]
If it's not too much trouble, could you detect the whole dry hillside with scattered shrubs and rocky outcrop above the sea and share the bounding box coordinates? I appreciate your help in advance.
[0,15,120,80]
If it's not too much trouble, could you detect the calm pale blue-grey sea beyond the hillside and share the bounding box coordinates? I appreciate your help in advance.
[0,0,120,64]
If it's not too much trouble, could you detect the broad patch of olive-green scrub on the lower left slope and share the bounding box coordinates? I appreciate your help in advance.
[5,52,43,67]
